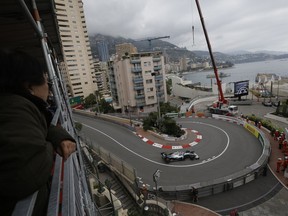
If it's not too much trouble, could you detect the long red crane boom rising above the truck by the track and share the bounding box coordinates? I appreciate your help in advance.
[195,0,227,104]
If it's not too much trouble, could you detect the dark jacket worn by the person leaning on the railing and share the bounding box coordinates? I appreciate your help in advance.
[0,94,73,214]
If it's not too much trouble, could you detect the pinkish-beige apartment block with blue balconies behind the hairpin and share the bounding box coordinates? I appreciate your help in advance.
[110,47,167,114]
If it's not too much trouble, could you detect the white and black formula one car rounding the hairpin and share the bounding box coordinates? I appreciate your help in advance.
[161,150,199,163]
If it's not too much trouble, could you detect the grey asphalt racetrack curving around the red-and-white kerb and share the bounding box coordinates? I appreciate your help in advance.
[73,114,262,187]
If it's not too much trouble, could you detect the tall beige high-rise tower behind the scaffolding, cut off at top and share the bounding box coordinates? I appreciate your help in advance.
[54,0,98,97]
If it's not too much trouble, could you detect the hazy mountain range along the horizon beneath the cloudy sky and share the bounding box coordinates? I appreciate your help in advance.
[89,34,288,64]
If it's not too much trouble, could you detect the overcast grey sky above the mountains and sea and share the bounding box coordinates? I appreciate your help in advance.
[83,0,288,52]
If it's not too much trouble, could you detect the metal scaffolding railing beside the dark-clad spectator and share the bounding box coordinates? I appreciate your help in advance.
[13,0,100,216]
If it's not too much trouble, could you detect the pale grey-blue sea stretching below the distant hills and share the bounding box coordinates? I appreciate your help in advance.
[182,59,288,87]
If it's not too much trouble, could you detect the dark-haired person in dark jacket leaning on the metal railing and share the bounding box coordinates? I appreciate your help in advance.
[0,51,76,216]
